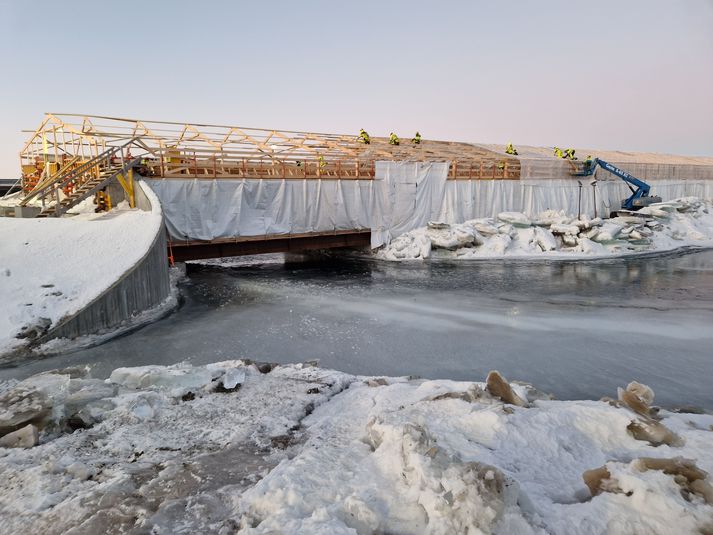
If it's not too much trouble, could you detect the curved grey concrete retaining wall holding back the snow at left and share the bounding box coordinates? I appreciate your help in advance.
[39,183,171,343]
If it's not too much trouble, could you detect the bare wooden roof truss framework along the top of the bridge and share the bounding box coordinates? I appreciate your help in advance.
[20,113,520,186]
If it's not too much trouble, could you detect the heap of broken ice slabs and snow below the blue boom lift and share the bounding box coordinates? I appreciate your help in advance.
[376,197,713,260]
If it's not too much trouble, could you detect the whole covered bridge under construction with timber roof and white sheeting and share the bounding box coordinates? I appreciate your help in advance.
[9,113,713,260]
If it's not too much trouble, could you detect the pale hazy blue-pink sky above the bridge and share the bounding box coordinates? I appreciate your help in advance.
[0,0,713,178]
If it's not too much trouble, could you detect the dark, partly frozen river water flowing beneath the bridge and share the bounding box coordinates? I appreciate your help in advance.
[0,251,713,409]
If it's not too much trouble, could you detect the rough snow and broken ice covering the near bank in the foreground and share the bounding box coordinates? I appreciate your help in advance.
[0,361,713,534]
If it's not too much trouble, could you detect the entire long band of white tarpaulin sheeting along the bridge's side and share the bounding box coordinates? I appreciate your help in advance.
[147,162,713,247]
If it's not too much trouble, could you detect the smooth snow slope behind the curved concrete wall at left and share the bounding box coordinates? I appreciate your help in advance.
[0,186,162,355]
